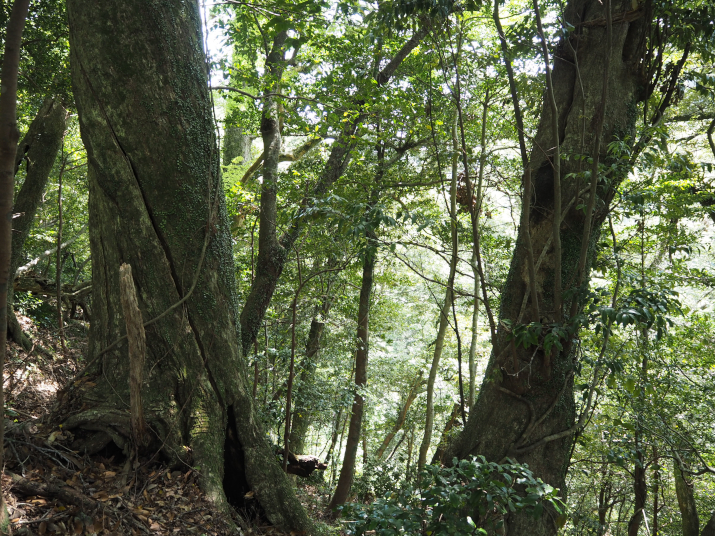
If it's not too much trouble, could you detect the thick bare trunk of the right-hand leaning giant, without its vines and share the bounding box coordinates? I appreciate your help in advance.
[446,0,648,536]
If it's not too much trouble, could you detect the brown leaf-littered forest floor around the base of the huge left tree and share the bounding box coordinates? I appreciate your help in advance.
[2,316,338,536]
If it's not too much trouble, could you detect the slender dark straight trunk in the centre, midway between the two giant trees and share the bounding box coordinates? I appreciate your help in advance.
[328,227,377,510]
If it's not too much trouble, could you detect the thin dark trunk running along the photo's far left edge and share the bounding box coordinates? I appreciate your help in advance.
[0,0,30,534]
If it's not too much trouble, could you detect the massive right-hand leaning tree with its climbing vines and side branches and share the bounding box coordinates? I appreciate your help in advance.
[447,0,712,536]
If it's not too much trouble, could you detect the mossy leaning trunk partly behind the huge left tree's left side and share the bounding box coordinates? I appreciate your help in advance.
[7,96,67,350]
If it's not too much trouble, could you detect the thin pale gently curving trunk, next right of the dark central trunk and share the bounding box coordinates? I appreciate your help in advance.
[417,118,459,471]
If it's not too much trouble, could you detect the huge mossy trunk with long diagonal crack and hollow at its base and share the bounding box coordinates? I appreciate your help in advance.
[59,0,311,532]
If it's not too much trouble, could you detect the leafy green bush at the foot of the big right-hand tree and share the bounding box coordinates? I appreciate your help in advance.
[343,456,562,536]
